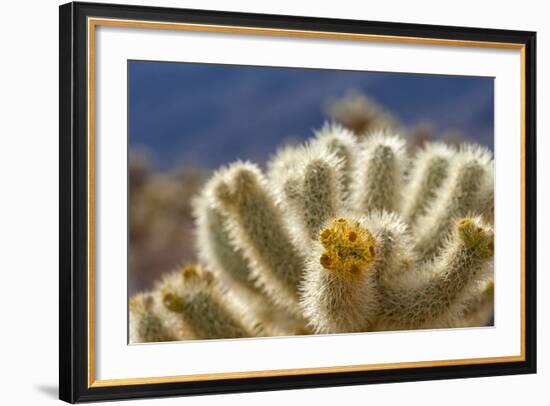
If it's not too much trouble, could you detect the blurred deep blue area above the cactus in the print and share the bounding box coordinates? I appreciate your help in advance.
[128,61,494,169]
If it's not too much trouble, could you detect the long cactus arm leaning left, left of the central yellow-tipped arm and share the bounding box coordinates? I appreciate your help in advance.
[211,162,304,311]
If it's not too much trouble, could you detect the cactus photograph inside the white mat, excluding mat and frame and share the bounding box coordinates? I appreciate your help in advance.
[127,59,495,344]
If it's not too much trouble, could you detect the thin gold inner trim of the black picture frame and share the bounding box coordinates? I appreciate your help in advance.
[87,18,526,388]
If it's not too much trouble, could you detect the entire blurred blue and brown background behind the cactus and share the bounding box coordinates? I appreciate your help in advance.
[128,61,494,295]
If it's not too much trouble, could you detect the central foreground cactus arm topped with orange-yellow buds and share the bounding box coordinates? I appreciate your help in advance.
[301,218,377,333]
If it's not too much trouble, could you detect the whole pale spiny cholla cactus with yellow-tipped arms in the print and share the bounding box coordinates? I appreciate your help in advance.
[131,125,494,342]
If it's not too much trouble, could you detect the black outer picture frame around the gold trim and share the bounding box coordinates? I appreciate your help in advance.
[59,2,536,403]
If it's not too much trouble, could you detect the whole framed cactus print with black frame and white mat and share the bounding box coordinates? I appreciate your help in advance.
[60,3,536,402]
